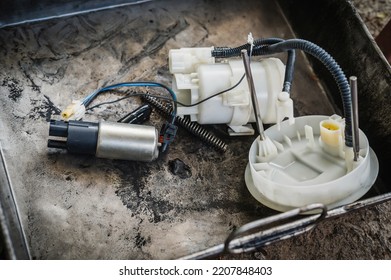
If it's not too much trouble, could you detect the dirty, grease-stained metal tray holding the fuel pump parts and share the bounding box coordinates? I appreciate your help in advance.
[0,0,391,259]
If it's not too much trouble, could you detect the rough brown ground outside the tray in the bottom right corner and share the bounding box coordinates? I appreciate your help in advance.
[255,202,391,260]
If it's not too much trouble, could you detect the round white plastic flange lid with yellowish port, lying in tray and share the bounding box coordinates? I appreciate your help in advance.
[245,116,378,211]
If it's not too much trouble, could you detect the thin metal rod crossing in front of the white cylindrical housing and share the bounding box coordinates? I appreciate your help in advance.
[242,50,265,141]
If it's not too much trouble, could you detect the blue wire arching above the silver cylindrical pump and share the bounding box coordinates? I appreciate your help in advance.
[82,82,177,124]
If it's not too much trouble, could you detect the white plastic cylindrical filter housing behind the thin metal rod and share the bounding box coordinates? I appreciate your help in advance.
[169,48,293,133]
